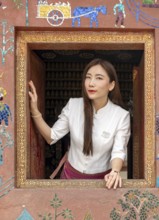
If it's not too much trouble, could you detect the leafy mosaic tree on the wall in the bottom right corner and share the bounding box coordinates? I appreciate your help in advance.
[110,189,159,220]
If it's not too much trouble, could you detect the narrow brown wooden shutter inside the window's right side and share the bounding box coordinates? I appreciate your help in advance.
[133,55,144,179]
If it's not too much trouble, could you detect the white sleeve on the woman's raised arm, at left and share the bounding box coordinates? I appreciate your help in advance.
[50,101,70,145]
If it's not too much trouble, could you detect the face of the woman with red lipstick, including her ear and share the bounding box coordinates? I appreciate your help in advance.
[85,64,115,102]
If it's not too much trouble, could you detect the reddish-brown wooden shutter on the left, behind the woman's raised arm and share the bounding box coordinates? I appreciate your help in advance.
[27,51,45,179]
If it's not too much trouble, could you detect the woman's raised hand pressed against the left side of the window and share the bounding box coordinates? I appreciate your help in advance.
[29,81,39,115]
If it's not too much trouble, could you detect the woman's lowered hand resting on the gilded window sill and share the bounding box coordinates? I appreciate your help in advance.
[104,170,122,189]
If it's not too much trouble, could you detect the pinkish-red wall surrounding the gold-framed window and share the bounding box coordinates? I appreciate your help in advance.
[0,0,159,220]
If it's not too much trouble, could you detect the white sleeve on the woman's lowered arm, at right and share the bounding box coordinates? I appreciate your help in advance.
[111,112,130,160]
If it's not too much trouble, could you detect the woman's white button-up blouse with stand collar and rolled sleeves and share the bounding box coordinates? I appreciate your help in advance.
[51,98,130,174]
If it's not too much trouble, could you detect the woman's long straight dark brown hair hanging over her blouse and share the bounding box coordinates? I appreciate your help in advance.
[82,59,124,155]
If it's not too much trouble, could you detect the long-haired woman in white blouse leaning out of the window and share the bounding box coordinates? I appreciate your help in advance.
[29,59,130,189]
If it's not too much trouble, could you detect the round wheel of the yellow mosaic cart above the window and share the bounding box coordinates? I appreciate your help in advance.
[47,9,64,26]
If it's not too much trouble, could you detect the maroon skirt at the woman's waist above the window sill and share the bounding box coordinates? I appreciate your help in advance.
[60,161,111,179]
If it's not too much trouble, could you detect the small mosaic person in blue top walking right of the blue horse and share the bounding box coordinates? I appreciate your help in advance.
[113,0,126,28]
